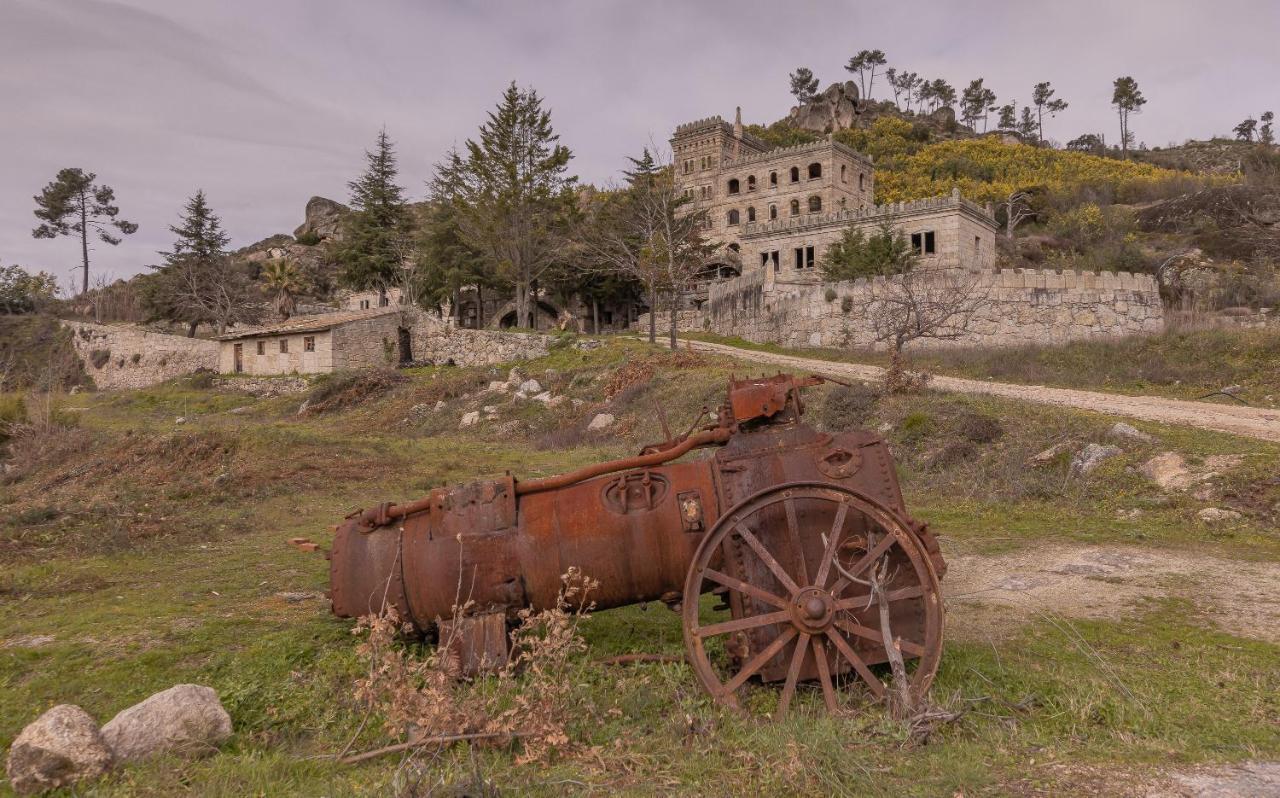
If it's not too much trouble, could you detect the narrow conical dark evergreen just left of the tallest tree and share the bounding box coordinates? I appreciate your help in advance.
[337,128,412,305]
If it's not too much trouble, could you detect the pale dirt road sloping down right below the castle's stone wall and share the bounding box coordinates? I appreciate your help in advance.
[682,339,1280,442]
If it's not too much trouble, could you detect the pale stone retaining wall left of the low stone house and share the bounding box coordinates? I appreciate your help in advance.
[65,322,218,391]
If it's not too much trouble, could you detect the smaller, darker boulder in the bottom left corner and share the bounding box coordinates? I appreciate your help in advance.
[8,703,115,795]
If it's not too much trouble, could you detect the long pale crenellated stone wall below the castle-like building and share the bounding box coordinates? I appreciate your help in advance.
[701,269,1164,348]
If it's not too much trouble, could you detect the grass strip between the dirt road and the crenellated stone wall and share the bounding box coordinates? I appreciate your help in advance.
[687,329,1280,407]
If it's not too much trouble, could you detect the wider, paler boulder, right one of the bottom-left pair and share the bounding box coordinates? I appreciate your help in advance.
[102,684,232,762]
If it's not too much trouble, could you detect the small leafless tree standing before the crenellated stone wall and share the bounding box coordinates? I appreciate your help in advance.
[854,268,989,392]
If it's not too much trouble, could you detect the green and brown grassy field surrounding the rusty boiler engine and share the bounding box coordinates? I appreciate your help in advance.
[0,342,1280,795]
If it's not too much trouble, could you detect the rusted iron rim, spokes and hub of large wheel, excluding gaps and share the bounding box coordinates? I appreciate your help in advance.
[682,483,943,717]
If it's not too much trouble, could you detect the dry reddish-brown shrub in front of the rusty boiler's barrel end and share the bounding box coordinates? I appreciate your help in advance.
[352,569,599,763]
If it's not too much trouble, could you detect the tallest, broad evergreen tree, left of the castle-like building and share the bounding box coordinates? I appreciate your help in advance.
[438,81,577,327]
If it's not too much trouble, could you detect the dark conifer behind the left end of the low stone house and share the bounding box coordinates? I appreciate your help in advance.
[142,191,257,336]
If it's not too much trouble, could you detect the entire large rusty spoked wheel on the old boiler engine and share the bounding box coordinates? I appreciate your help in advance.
[682,483,943,717]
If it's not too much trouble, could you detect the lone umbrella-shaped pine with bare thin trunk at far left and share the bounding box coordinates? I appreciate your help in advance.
[31,169,138,291]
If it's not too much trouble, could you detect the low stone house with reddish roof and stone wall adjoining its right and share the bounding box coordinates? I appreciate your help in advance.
[218,306,548,375]
